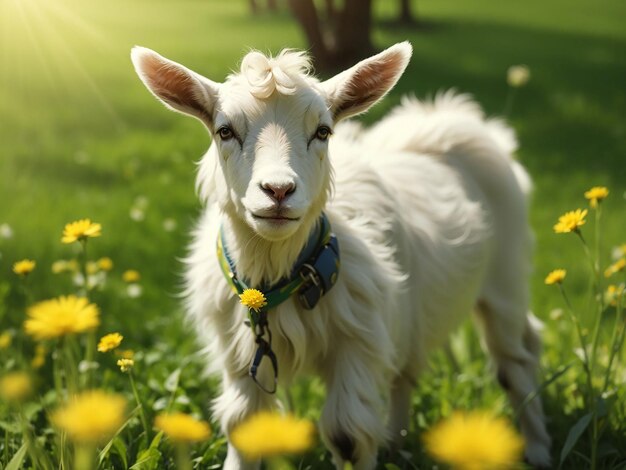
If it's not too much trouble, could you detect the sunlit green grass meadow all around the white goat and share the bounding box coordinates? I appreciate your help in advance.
[0,0,626,469]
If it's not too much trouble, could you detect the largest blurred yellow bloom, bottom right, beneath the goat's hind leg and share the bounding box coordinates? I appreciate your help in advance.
[423,411,524,470]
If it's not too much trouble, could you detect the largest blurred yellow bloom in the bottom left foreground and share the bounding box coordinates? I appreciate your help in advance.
[51,390,126,444]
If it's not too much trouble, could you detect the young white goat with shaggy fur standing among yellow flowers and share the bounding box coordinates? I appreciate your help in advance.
[132,43,550,469]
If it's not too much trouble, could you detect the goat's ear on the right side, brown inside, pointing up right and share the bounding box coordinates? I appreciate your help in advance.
[322,41,413,121]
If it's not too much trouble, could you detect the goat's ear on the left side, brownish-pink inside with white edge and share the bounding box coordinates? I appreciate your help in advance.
[130,46,219,126]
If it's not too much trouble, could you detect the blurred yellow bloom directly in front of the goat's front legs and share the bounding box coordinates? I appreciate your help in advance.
[230,411,315,460]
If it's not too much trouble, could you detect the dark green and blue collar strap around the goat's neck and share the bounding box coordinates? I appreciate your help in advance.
[217,213,340,310]
